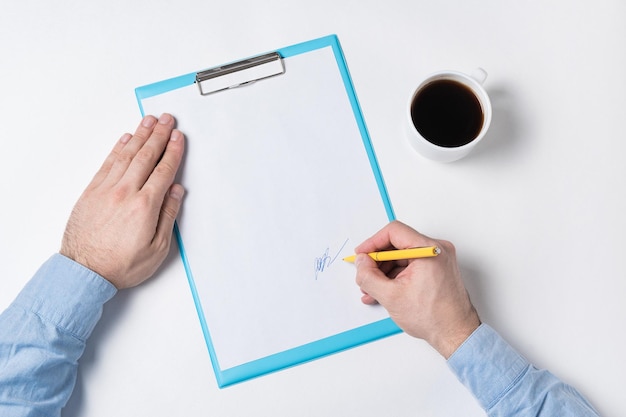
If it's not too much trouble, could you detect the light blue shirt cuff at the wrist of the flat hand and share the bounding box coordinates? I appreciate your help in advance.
[13,253,117,341]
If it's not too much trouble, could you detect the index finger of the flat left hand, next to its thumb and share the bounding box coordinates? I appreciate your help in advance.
[142,129,185,198]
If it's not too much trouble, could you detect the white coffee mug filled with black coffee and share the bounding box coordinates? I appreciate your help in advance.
[407,68,491,162]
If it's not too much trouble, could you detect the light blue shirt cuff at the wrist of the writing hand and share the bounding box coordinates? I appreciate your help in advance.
[448,323,530,410]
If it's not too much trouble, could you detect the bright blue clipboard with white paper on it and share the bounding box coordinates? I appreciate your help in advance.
[136,35,401,387]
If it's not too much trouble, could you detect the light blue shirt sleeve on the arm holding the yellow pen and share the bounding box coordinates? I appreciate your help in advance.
[448,323,598,417]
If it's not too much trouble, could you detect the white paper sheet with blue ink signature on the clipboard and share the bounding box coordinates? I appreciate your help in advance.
[142,47,388,369]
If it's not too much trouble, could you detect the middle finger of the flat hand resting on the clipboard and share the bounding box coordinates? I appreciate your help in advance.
[122,113,174,189]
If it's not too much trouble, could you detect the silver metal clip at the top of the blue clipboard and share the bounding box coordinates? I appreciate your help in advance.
[196,52,285,96]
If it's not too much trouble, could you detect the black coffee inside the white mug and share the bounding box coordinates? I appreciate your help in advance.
[411,80,484,148]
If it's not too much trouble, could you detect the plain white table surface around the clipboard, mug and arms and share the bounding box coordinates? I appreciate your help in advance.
[0,0,626,417]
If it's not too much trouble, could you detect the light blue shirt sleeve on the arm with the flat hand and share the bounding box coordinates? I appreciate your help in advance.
[0,254,117,417]
